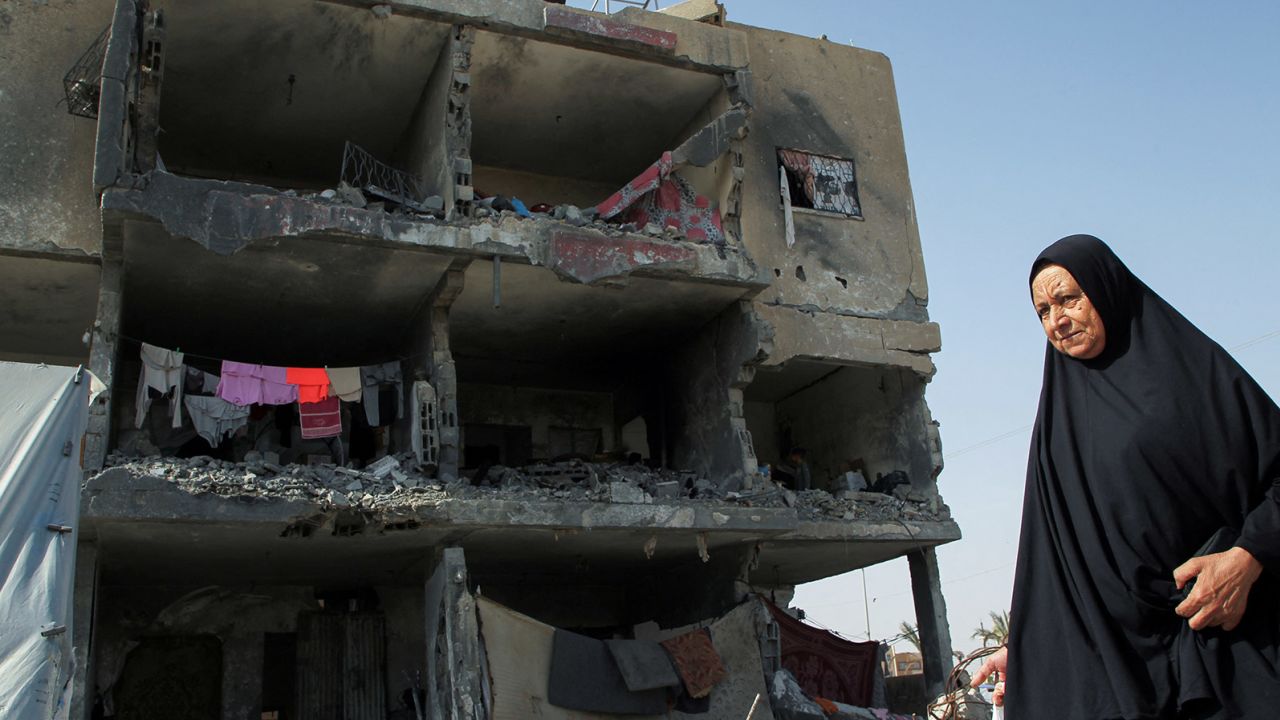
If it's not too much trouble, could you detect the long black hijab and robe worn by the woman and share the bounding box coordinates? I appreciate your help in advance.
[1006,234,1280,720]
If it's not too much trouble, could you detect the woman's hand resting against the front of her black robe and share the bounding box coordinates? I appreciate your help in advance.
[1174,547,1262,630]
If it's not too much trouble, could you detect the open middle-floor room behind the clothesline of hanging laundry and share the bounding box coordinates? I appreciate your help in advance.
[114,220,449,462]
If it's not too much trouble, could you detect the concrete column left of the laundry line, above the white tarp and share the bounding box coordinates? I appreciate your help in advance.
[84,258,124,471]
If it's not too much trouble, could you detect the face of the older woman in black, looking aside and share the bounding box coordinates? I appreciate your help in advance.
[1032,265,1107,360]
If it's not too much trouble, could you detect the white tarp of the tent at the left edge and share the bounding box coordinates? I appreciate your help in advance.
[0,363,97,720]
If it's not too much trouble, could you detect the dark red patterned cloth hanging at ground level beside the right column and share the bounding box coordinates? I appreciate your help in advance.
[767,602,879,707]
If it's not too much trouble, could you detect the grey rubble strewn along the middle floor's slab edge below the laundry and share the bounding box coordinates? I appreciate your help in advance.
[94,452,950,520]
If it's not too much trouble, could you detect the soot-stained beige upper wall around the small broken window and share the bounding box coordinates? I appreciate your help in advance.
[733,26,928,322]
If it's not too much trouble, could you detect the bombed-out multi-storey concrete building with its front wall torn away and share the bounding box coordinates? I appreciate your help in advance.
[0,0,960,719]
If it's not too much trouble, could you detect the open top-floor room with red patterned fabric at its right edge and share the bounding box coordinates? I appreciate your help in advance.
[471,31,727,208]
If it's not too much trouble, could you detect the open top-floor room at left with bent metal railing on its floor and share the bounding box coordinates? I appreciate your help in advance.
[151,0,452,193]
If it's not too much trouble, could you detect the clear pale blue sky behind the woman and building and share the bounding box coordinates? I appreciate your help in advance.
[571,0,1280,650]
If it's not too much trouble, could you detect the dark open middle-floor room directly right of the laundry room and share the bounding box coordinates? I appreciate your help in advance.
[449,261,742,470]
